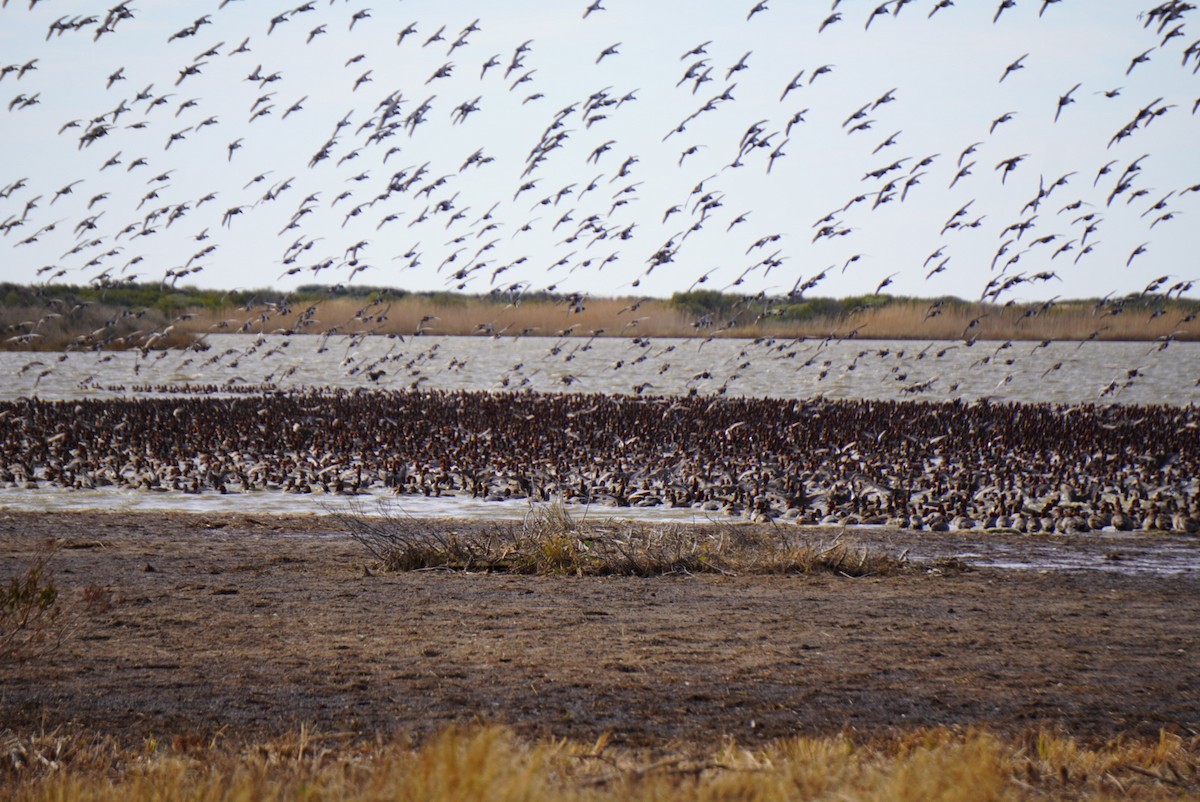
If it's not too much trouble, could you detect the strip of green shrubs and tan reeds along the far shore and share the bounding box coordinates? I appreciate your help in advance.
[0,283,1200,351]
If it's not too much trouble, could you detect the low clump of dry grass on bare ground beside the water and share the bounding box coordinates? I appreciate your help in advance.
[337,503,911,577]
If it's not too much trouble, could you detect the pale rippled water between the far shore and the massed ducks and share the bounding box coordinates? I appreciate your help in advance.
[0,335,1200,406]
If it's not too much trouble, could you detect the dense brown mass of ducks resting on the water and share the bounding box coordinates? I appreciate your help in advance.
[0,390,1200,533]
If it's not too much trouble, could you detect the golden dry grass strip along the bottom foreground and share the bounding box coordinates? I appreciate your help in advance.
[0,726,1200,802]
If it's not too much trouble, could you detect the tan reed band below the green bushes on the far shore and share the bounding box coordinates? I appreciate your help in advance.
[166,295,1200,341]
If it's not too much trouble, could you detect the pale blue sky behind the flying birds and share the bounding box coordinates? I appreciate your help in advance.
[0,0,1200,303]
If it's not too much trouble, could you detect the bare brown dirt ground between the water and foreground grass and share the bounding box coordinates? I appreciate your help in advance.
[0,513,1200,746]
